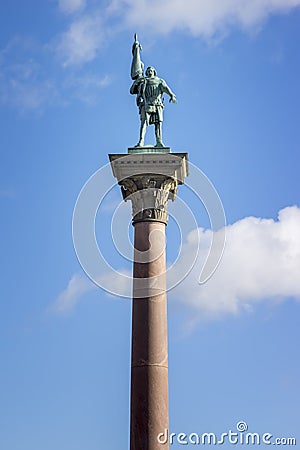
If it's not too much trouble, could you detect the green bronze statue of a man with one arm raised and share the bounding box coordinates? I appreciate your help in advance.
[130,35,176,147]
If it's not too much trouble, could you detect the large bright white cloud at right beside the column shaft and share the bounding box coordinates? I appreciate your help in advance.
[169,206,300,317]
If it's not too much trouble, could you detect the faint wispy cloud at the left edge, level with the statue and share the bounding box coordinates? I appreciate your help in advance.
[0,38,111,114]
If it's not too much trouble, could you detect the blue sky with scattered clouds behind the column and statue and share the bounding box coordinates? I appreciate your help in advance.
[0,0,300,450]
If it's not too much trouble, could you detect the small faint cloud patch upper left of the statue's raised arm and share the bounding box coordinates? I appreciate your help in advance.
[57,14,104,67]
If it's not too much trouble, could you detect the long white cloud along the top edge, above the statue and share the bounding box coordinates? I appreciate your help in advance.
[110,0,300,37]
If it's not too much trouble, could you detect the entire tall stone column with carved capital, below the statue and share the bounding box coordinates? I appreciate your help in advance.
[109,153,187,450]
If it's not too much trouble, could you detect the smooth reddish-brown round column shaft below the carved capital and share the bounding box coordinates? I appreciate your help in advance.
[130,222,169,450]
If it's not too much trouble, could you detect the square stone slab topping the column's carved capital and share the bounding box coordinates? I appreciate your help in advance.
[109,153,188,184]
